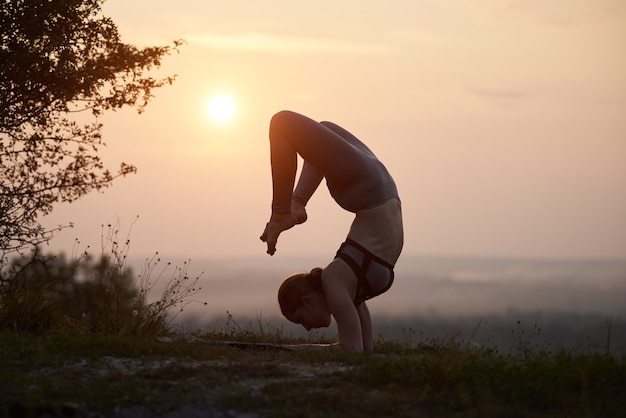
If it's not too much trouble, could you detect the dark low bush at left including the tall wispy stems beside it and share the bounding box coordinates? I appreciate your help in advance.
[0,225,200,335]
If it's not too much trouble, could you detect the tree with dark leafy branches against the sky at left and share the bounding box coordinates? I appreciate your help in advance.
[0,0,181,267]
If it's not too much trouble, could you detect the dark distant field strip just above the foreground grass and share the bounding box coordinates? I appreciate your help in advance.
[186,311,626,355]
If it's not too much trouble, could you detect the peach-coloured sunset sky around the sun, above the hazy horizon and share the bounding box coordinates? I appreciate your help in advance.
[42,0,626,261]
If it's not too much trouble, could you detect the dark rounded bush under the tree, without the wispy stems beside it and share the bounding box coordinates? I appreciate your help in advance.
[0,251,150,334]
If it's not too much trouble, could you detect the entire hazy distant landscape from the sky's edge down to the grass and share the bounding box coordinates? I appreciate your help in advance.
[145,253,626,353]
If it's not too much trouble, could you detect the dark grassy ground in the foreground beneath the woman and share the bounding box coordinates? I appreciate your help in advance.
[0,329,626,418]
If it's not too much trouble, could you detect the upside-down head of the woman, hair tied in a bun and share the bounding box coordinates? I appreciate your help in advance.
[278,267,330,330]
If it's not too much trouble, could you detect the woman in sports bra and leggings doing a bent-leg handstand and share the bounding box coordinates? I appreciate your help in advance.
[261,111,403,352]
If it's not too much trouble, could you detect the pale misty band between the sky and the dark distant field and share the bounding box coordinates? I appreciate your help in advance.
[114,257,626,319]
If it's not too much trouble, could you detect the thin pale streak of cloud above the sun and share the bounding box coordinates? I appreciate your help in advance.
[185,32,392,54]
